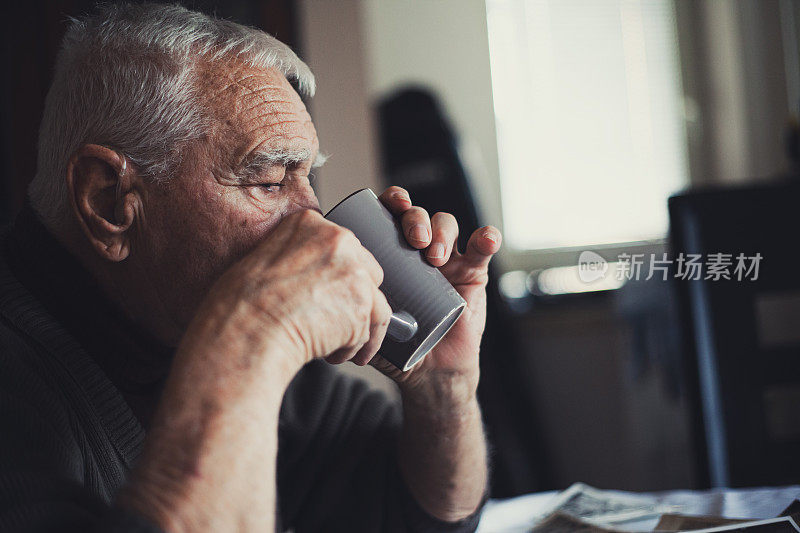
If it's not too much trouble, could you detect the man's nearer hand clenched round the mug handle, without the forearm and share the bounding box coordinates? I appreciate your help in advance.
[208,206,392,375]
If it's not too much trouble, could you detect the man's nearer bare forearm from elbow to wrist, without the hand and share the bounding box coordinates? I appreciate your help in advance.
[118,302,293,532]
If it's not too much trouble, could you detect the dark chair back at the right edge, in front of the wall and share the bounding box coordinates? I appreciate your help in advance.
[669,180,800,487]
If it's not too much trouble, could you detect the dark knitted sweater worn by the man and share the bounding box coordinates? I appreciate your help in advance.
[0,203,479,532]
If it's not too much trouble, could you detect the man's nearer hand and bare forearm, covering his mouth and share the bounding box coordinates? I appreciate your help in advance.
[120,210,391,532]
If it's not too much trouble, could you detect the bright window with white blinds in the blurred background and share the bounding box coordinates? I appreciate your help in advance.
[486,0,688,250]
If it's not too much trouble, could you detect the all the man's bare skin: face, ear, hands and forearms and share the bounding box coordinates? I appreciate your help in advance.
[61,63,500,531]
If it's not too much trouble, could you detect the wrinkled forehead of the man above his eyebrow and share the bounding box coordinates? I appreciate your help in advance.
[198,62,319,160]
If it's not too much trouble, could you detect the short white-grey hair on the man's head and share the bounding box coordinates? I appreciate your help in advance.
[28,4,315,231]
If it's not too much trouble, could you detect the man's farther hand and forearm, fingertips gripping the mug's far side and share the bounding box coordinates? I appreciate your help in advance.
[371,187,500,521]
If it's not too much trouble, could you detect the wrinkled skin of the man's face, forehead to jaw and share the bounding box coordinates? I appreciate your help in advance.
[126,66,319,336]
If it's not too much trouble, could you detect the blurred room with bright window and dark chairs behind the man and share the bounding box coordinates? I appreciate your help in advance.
[0,0,800,497]
